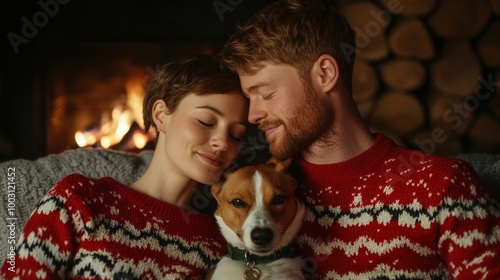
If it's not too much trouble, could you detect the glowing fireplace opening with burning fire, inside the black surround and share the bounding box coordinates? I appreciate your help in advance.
[39,43,215,153]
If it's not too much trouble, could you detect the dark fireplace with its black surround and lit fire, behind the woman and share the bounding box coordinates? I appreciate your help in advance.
[0,0,271,161]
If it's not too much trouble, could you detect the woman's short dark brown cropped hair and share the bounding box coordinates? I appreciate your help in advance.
[143,54,241,132]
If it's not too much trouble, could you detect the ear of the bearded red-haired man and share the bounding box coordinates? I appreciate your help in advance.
[311,54,340,92]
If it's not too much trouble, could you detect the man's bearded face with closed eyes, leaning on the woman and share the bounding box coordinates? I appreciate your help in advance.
[240,63,333,159]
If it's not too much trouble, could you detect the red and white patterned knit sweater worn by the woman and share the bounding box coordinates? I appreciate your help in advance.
[1,174,227,279]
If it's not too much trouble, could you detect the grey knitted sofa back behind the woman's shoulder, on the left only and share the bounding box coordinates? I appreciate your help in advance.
[0,148,153,261]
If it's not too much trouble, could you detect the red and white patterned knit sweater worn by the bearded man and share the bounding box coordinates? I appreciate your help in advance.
[296,134,500,280]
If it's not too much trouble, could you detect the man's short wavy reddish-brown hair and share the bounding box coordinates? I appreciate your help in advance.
[221,0,355,91]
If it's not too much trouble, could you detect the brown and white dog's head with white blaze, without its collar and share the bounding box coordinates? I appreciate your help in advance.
[212,159,304,255]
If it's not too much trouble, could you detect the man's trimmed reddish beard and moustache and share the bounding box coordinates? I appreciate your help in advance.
[261,83,333,160]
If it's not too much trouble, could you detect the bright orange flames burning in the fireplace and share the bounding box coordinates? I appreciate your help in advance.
[75,77,154,150]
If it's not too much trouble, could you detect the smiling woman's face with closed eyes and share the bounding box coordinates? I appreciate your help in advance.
[165,92,248,184]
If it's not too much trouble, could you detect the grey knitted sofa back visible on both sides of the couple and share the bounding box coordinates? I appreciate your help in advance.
[0,148,500,261]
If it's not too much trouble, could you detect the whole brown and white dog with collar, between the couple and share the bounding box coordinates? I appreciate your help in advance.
[206,158,305,280]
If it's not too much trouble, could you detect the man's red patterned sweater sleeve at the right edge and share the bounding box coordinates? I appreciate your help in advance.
[436,163,500,279]
